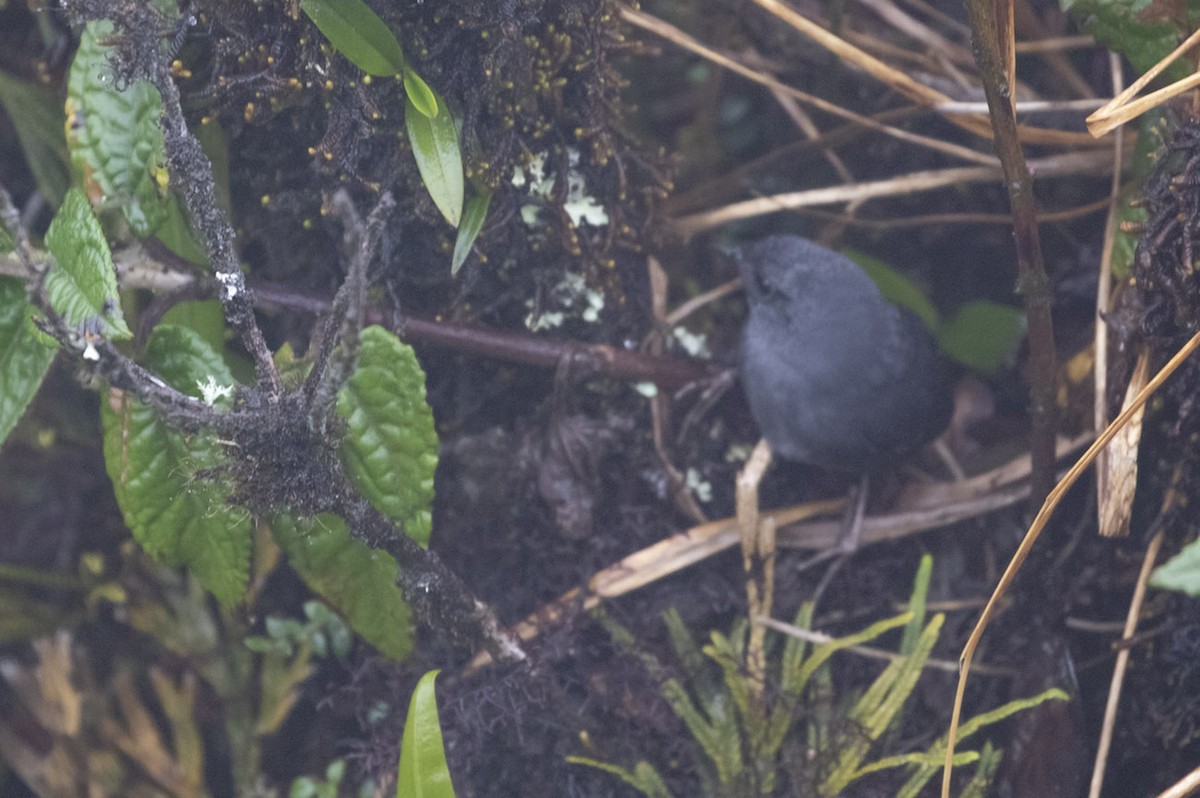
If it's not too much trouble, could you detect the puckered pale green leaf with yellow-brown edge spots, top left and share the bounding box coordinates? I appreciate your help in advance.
[66,20,170,238]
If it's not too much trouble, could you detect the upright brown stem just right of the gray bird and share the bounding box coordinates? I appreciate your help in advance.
[967,0,1058,505]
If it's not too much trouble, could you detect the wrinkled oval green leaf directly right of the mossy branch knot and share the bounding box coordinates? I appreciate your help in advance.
[337,326,438,546]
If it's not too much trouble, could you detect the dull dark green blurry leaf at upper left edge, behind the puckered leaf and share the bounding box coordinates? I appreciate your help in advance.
[0,72,71,208]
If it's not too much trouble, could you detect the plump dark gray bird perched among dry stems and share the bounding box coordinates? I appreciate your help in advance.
[733,235,952,474]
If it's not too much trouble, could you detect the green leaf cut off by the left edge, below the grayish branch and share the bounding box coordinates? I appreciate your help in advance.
[0,277,58,445]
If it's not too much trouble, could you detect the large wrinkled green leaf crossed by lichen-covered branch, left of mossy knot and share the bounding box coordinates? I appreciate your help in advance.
[101,324,251,604]
